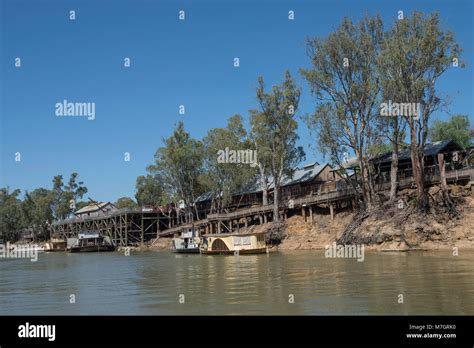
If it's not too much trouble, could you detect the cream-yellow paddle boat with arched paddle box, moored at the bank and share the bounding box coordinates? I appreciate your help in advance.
[200,232,268,255]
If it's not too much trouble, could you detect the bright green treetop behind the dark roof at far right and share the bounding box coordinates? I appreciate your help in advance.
[429,115,472,149]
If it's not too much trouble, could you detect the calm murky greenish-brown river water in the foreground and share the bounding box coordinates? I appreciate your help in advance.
[0,250,474,315]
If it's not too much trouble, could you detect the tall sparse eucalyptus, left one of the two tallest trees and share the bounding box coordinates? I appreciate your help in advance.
[301,16,383,210]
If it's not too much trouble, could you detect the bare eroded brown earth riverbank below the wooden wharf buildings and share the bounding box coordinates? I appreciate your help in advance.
[146,185,474,251]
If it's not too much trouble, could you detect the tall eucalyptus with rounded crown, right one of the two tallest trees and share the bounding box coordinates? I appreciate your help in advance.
[379,11,463,211]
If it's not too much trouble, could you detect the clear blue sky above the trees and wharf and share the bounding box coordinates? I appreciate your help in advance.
[0,0,474,200]
